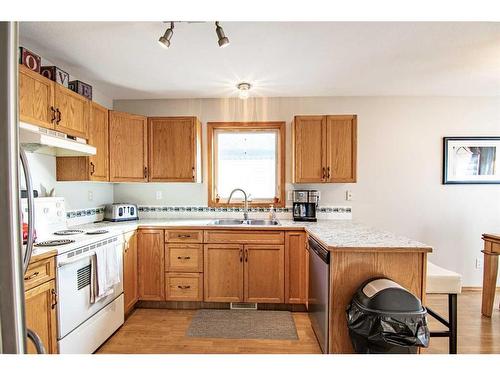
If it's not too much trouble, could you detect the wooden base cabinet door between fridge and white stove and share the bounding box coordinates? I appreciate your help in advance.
[24,280,57,354]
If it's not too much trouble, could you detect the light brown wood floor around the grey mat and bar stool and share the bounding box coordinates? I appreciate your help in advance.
[97,292,500,354]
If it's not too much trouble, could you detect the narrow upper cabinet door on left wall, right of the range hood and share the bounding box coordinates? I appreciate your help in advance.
[88,102,109,181]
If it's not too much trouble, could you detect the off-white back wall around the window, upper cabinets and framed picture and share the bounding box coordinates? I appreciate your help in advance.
[114,97,500,286]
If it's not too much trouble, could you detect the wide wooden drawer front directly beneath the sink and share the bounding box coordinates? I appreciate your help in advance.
[205,230,285,245]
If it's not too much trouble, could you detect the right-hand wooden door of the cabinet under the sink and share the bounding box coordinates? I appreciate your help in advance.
[244,245,285,303]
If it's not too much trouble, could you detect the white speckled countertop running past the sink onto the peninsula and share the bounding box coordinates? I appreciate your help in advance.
[71,219,432,252]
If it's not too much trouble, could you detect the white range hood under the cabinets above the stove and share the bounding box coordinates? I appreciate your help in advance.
[19,122,96,156]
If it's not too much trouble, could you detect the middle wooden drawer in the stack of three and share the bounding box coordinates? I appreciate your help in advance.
[165,243,203,272]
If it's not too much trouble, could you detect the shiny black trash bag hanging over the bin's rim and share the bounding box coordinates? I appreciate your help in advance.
[346,300,430,354]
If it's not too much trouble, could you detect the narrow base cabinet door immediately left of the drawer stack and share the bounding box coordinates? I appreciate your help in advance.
[137,229,165,301]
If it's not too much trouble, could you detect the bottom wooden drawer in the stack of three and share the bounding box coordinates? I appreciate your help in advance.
[165,273,203,301]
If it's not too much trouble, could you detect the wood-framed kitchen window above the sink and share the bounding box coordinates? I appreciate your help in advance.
[208,122,285,207]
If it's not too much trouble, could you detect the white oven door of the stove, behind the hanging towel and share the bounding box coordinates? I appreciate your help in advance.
[57,243,123,340]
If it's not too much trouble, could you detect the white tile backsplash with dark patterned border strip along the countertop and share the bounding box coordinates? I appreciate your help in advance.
[66,206,352,226]
